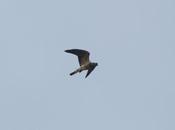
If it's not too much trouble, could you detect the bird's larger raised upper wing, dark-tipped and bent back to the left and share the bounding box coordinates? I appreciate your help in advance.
[65,49,90,66]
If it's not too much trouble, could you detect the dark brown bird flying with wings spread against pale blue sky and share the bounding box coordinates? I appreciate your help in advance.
[65,49,98,78]
